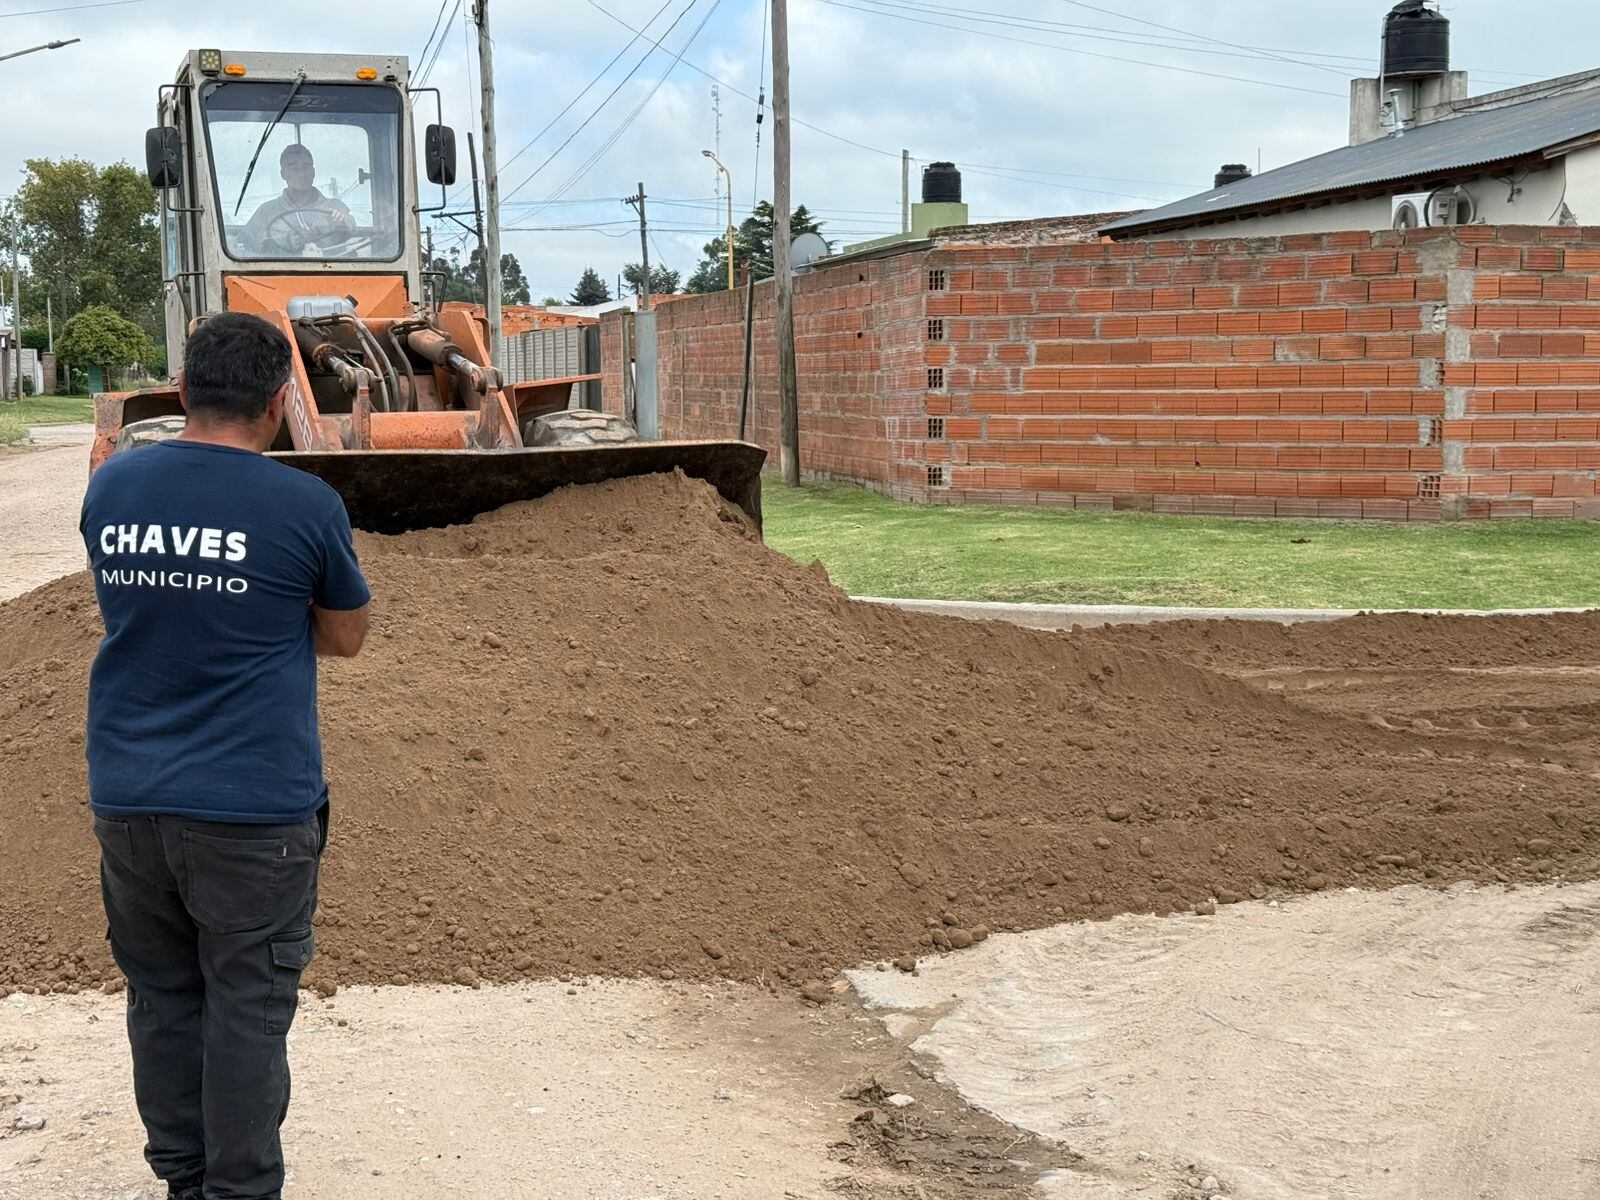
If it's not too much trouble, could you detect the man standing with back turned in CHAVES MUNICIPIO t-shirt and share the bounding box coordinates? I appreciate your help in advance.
[80,314,370,1200]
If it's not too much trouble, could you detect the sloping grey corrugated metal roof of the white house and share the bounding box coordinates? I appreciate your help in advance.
[1101,86,1600,234]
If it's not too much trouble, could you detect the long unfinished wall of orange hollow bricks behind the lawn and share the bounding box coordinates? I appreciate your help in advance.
[608,227,1600,518]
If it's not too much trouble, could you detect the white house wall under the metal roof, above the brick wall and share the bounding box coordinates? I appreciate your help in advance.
[1136,162,1568,238]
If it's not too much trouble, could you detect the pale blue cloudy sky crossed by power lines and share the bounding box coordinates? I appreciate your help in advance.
[0,0,1600,301]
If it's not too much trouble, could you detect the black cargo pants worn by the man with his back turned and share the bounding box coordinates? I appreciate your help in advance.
[94,805,328,1200]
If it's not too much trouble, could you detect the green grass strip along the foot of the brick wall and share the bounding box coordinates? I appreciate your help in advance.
[762,475,1600,608]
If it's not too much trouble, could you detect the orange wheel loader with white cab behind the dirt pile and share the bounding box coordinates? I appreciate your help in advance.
[90,50,765,533]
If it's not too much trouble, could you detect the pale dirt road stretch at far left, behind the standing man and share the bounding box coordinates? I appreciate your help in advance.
[0,426,94,600]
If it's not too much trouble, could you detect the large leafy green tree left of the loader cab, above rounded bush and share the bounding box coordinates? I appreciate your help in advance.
[8,158,163,336]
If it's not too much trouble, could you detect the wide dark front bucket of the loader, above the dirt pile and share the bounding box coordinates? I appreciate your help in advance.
[272,442,766,533]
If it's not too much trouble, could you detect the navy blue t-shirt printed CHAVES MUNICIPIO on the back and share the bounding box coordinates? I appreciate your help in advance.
[78,442,370,824]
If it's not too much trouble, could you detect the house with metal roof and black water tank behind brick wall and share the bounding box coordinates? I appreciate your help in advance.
[1101,0,1600,240]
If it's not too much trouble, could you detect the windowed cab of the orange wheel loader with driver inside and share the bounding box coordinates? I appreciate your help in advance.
[146,50,454,373]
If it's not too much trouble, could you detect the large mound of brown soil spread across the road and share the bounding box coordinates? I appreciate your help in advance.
[0,477,1600,994]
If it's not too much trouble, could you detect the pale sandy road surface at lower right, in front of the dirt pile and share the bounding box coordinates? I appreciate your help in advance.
[851,883,1600,1200]
